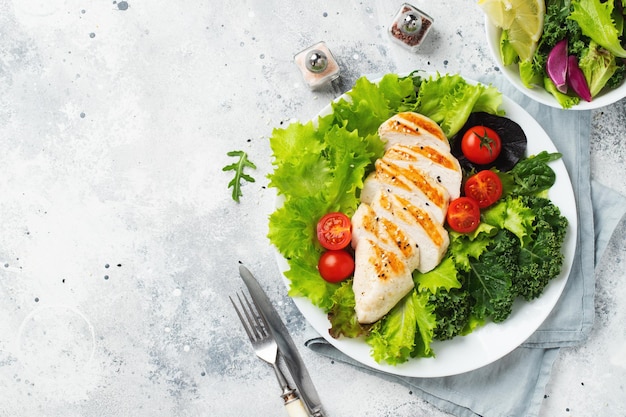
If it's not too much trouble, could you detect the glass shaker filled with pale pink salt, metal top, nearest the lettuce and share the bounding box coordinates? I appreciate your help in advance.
[294,41,339,90]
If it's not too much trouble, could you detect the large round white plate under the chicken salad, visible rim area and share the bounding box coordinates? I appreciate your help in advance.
[277,75,578,377]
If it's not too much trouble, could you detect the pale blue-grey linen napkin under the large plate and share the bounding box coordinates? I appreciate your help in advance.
[305,77,626,417]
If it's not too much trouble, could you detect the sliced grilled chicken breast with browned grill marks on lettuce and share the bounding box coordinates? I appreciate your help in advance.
[352,112,462,323]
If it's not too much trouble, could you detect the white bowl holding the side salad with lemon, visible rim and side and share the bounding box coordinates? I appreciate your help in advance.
[485,19,626,110]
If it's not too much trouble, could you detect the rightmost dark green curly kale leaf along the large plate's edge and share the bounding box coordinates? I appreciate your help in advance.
[513,197,568,300]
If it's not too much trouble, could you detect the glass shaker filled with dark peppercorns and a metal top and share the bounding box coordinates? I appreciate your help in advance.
[389,3,434,52]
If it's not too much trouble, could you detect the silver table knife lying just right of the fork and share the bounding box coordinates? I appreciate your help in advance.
[239,265,324,417]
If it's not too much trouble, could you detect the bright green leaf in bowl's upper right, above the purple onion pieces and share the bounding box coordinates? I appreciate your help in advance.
[569,0,626,58]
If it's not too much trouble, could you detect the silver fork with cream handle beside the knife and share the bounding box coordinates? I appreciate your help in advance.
[228,293,309,417]
